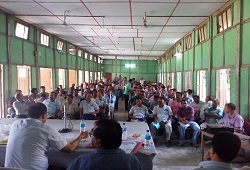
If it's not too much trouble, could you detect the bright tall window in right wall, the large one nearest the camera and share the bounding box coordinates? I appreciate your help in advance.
[216,69,230,107]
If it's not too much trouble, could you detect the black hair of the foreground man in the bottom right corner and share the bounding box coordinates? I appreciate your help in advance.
[212,132,241,162]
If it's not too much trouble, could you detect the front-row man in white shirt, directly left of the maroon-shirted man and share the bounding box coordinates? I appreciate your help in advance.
[150,97,173,147]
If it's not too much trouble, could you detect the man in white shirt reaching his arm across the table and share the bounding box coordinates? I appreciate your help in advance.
[4,103,88,170]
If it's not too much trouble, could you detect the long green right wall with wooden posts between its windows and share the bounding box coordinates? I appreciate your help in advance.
[157,0,250,119]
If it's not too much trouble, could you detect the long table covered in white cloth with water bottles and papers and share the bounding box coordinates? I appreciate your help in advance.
[0,119,156,170]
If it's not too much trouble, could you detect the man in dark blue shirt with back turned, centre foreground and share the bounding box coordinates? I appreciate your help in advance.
[68,119,141,170]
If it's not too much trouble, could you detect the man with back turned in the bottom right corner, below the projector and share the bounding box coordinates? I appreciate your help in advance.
[196,132,241,170]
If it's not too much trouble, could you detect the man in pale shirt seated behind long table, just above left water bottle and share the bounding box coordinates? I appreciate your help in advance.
[79,93,100,120]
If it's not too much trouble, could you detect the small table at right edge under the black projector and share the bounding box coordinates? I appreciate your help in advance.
[201,130,250,161]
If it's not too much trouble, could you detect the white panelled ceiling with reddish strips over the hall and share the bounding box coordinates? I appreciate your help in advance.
[0,0,228,60]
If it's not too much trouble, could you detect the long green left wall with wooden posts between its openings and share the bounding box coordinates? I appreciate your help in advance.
[0,11,102,115]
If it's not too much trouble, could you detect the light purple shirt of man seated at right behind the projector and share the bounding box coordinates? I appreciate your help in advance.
[222,112,244,130]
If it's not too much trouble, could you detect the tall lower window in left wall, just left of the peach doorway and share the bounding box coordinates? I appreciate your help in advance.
[17,66,31,95]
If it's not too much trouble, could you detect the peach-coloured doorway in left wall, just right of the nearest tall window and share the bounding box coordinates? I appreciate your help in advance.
[40,68,53,92]
